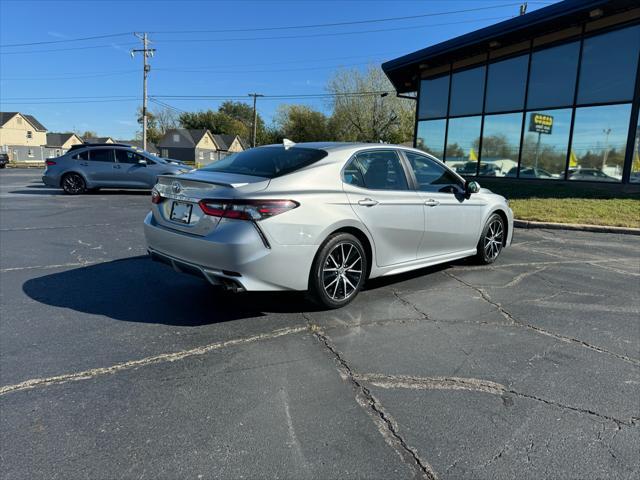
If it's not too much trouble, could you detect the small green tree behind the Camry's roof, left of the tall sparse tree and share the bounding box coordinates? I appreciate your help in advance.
[275,105,330,142]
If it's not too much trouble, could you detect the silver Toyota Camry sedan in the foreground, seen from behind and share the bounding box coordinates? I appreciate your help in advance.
[144,140,513,308]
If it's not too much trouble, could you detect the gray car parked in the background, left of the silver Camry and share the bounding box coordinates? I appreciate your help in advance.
[42,144,190,195]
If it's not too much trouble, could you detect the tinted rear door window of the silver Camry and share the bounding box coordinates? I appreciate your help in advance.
[344,150,409,190]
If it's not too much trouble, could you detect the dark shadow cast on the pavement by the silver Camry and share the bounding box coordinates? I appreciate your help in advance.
[22,256,314,326]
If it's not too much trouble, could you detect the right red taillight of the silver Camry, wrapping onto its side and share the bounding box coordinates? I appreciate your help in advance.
[199,200,300,221]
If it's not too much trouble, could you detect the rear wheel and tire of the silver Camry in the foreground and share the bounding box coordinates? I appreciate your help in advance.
[309,233,368,309]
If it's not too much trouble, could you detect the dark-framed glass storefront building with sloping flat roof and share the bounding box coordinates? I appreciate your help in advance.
[383,0,640,184]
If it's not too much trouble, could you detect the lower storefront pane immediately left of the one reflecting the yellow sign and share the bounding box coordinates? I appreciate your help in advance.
[479,113,523,177]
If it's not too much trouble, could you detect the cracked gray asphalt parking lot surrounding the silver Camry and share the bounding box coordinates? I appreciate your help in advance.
[0,170,640,479]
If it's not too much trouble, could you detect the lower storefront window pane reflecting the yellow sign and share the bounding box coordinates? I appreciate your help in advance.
[520,108,571,180]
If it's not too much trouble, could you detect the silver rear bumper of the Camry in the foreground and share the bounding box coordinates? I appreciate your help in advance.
[144,213,318,291]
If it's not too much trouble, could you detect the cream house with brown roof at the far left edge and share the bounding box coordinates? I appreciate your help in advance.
[0,112,47,162]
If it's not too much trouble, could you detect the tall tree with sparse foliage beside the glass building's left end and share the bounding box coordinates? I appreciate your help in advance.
[327,65,415,143]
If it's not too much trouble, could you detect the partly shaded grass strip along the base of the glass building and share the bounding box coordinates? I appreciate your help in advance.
[480,179,640,228]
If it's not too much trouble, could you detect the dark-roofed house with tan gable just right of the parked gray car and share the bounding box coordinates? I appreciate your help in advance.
[158,128,221,165]
